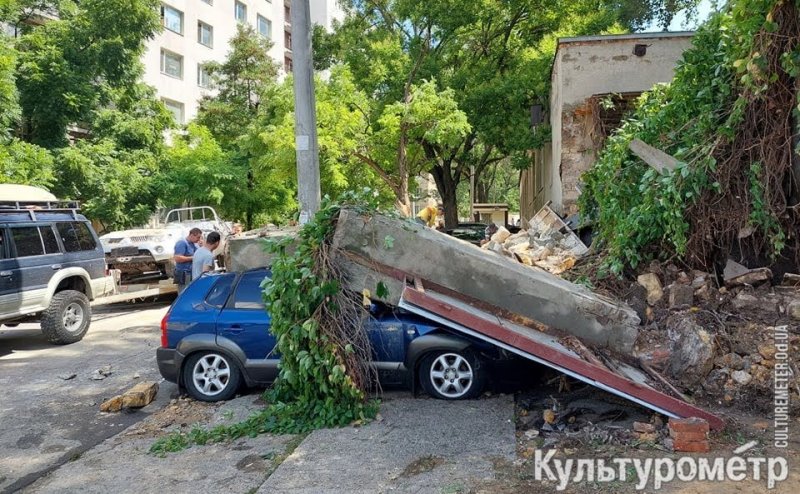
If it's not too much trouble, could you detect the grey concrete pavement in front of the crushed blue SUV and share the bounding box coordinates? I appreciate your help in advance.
[23,392,515,494]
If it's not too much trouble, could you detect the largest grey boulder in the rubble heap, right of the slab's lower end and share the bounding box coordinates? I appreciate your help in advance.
[666,312,714,385]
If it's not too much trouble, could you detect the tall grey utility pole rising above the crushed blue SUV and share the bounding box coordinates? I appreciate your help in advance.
[292,0,320,225]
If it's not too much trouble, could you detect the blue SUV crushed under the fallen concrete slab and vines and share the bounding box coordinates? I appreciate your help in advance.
[156,269,505,401]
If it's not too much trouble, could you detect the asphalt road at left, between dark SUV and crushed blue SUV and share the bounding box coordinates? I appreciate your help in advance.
[0,302,177,493]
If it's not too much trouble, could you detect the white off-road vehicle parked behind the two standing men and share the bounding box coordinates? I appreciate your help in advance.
[100,206,231,281]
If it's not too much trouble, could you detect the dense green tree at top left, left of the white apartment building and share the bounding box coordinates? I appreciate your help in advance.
[16,0,160,148]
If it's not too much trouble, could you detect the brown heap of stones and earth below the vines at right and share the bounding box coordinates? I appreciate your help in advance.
[623,261,800,410]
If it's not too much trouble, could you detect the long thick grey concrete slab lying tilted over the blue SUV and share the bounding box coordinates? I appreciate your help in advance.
[333,210,639,354]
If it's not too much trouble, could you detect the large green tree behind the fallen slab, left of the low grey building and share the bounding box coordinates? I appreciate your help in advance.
[316,0,695,224]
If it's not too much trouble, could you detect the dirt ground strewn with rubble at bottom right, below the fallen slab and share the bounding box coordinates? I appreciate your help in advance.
[470,376,800,494]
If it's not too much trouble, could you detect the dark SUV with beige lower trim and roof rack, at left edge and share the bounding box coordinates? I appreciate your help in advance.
[0,200,114,345]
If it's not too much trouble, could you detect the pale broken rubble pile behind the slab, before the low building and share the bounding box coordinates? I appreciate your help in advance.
[482,206,589,274]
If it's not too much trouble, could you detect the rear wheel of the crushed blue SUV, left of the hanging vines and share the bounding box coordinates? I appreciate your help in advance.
[183,352,242,401]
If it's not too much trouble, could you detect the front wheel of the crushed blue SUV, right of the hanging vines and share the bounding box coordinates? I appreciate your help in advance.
[419,350,486,400]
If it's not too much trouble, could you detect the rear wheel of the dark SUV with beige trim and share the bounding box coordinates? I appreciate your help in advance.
[41,290,92,345]
